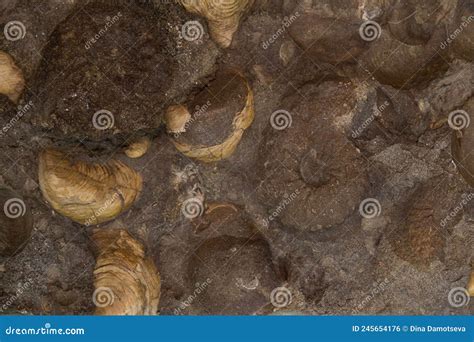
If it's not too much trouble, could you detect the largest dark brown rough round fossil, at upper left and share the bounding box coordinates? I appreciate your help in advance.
[32,1,176,140]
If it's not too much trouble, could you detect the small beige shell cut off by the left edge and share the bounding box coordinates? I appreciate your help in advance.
[0,51,25,103]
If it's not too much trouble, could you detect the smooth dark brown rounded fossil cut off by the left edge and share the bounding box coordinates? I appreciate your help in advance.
[0,186,33,256]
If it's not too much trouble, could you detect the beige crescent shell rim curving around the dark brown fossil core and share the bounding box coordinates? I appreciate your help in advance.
[168,74,255,162]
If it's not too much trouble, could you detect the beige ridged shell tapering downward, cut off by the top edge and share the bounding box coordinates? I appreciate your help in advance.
[180,0,254,48]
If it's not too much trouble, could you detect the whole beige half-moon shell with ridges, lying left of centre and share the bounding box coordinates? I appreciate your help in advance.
[39,149,142,225]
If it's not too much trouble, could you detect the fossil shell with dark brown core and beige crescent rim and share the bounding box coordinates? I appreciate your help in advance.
[166,71,254,162]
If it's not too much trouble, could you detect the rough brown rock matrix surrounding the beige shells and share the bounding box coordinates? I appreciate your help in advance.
[0,0,474,315]
